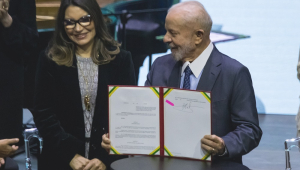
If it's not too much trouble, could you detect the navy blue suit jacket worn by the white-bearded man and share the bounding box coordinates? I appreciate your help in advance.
[145,47,262,163]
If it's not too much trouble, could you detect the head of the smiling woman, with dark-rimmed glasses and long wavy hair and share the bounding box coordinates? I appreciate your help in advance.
[47,0,120,67]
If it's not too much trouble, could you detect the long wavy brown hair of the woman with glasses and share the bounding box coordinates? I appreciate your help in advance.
[46,0,120,67]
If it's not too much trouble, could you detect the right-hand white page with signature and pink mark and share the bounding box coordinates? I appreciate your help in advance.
[164,88,211,160]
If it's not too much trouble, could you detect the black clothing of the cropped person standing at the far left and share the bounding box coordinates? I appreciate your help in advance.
[0,0,38,143]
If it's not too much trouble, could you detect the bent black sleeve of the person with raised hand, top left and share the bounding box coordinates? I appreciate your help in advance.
[0,0,38,60]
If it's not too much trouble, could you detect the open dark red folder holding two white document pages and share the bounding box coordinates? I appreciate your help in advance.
[108,86,211,161]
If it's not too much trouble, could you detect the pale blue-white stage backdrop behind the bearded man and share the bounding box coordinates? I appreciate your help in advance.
[139,0,300,115]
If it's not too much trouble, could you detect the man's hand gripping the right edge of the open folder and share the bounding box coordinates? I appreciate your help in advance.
[201,135,225,155]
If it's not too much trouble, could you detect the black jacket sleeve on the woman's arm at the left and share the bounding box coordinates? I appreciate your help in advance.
[32,54,84,163]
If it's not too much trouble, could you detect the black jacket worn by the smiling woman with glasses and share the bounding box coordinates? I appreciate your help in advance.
[33,50,135,170]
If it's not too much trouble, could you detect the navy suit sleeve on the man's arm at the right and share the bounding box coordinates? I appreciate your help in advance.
[222,66,262,158]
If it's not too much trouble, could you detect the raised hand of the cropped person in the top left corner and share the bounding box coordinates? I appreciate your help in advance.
[0,0,12,27]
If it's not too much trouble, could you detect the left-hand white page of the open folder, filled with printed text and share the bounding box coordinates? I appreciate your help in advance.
[109,87,160,155]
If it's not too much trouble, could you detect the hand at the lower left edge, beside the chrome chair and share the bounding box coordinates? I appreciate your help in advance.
[0,138,19,158]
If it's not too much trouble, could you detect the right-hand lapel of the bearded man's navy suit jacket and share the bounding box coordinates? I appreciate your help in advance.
[197,46,222,91]
